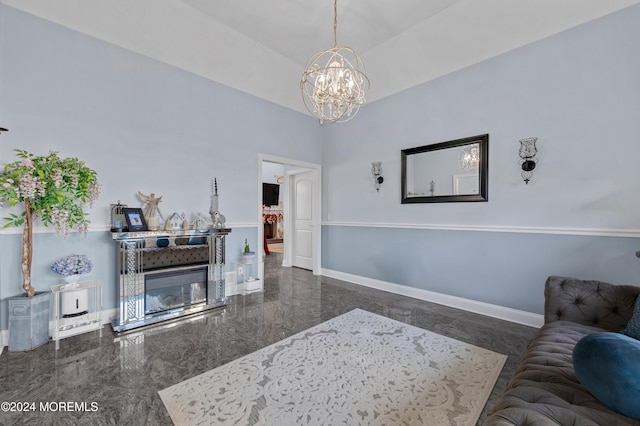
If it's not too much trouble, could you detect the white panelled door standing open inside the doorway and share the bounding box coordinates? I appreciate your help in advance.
[293,172,314,269]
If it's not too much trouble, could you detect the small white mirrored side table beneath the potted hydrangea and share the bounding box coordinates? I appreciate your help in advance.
[51,280,102,350]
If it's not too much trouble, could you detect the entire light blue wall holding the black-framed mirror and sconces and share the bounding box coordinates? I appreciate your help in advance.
[323,6,640,313]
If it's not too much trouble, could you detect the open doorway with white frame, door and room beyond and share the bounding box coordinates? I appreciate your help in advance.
[258,154,322,275]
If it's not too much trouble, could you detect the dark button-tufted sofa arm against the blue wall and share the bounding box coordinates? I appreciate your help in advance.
[544,276,640,331]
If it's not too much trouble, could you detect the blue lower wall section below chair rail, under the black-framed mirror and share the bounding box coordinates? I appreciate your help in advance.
[322,226,640,314]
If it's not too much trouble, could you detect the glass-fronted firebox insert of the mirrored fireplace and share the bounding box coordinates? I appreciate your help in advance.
[144,266,208,315]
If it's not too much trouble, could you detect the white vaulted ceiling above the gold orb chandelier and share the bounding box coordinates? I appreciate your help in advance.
[0,0,640,113]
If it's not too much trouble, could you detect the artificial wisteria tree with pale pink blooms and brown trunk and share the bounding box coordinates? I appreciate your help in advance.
[0,149,100,297]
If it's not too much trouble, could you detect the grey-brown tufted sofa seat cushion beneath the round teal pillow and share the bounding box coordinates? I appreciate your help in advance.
[484,321,640,426]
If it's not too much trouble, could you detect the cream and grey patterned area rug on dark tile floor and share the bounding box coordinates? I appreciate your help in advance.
[159,309,507,425]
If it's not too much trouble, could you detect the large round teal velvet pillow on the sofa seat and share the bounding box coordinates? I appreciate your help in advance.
[573,332,640,420]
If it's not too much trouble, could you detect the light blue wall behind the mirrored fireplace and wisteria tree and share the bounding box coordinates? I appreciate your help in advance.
[0,5,322,330]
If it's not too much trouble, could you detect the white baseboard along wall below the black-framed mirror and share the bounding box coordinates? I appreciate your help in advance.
[322,269,544,328]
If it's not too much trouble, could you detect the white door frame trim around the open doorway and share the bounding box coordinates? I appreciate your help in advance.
[256,154,322,275]
